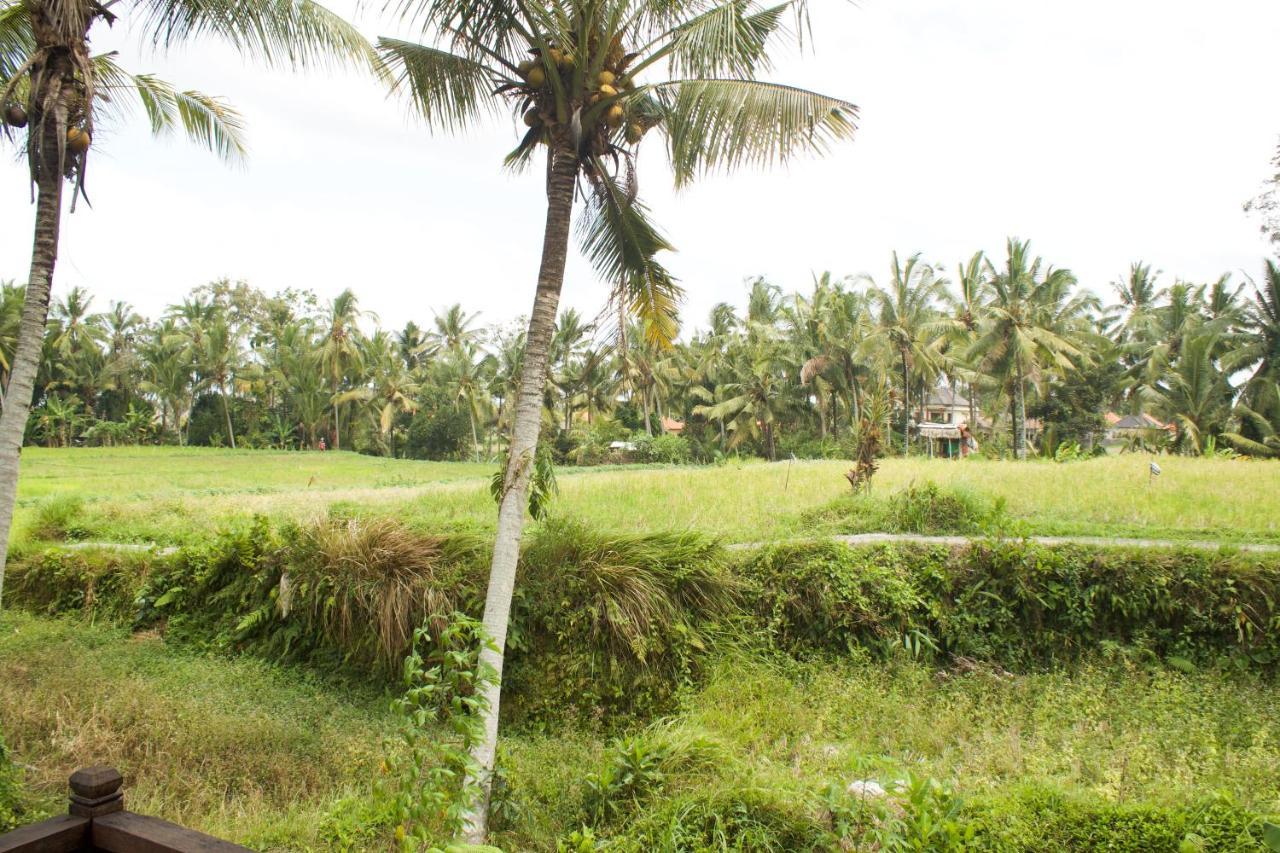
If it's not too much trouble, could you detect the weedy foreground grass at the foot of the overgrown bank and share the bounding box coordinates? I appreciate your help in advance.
[0,613,1280,850]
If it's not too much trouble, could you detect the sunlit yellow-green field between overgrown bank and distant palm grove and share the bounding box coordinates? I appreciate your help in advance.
[17,448,1280,544]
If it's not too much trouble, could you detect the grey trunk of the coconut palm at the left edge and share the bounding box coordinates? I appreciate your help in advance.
[0,69,72,606]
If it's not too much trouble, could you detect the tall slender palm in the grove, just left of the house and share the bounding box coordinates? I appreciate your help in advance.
[868,252,947,456]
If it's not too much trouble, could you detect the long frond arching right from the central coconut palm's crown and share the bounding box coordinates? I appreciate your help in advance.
[652,79,858,186]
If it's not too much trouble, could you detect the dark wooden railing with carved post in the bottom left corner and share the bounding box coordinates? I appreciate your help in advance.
[0,767,248,853]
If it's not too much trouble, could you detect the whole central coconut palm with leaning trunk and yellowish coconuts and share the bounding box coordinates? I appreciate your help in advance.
[379,0,856,839]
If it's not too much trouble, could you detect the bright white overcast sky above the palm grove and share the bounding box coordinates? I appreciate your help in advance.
[0,0,1280,328]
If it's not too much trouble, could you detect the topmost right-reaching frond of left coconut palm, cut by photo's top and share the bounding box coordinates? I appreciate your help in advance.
[133,0,376,68]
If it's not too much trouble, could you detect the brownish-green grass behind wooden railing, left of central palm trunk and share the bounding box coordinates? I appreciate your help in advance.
[0,611,392,849]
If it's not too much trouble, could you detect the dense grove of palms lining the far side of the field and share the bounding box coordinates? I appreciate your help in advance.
[0,241,1280,464]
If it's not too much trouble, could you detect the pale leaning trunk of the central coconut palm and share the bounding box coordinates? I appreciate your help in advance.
[466,138,577,843]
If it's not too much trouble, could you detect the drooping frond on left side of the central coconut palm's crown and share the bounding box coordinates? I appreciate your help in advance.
[378,38,506,132]
